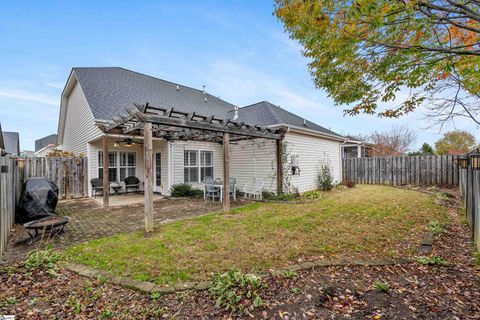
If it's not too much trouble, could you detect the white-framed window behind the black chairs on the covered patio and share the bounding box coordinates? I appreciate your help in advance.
[98,151,137,182]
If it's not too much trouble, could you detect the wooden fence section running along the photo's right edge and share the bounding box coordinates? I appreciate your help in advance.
[459,154,480,250]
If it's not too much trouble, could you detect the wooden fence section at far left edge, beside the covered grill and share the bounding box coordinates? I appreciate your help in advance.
[0,155,21,258]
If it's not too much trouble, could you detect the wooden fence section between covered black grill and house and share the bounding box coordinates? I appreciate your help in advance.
[23,157,88,199]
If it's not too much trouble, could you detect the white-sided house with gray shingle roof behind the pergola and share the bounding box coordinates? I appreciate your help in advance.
[58,67,347,195]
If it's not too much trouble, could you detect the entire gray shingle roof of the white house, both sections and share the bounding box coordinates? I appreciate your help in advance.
[70,67,343,138]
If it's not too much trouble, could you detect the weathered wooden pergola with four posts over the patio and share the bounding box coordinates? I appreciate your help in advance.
[97,103,285,232]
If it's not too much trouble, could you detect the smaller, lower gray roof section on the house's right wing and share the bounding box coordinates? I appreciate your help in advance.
[234,101,343,138]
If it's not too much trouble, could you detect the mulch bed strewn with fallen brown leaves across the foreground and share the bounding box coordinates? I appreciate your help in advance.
[0,190,480,320]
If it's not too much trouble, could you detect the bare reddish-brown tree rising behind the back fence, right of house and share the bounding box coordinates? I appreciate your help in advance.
[368,125,417,157]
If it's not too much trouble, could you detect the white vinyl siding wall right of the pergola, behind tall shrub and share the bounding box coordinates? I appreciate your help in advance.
[285,133,341,192]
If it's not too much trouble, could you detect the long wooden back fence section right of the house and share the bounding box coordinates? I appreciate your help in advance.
[343,156,458,186]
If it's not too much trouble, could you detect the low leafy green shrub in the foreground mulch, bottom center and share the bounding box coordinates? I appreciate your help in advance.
[210,268,262,315]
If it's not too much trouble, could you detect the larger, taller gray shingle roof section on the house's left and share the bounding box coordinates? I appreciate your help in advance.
[73,67,234,120]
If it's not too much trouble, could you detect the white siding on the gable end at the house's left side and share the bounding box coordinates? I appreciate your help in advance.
[59,82,102,155]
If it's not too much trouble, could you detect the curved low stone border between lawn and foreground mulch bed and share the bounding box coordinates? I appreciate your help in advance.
[65,258,413,295]
